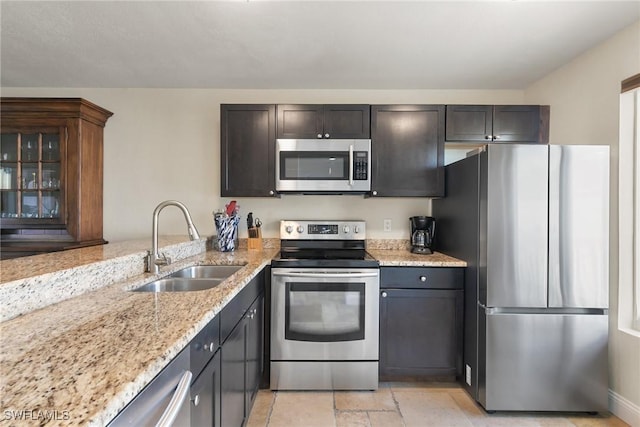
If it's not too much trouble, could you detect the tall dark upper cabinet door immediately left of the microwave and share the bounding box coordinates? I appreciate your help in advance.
[220,105,276,197]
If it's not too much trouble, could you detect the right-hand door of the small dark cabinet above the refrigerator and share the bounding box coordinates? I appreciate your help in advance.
[493,105,540,143]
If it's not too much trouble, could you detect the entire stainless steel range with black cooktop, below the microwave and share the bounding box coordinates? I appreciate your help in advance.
[271,221,380,390]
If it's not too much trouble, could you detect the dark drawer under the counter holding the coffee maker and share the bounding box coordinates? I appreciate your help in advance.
[380,267,464,289]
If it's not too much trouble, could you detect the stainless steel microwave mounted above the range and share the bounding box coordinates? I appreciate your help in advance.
[276,139,371,193]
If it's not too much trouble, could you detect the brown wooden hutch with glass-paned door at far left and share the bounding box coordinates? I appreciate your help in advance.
[0,98,113,259]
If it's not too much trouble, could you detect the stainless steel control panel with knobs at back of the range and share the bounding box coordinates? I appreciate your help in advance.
[280,220,366,240]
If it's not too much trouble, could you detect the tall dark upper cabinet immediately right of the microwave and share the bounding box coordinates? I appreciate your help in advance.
[371,105,445,197]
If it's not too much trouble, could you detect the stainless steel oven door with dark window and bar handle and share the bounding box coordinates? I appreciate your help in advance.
[271,268,380,361]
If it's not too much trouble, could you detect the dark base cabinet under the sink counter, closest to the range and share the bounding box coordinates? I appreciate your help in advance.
[220,272,264,426]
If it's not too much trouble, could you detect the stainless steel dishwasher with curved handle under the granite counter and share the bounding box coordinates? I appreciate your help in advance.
[108,346,193,427]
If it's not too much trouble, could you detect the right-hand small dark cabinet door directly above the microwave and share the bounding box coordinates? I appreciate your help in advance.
[323,104,371,139]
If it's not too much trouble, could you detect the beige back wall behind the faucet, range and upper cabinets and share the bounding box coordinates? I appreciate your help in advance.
[2,88,523,241]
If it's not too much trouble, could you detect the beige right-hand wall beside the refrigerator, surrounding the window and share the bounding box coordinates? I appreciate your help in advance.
[525,22,640,426]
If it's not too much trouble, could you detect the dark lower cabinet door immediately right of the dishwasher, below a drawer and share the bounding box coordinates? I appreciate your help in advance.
[191,351,221,427]
